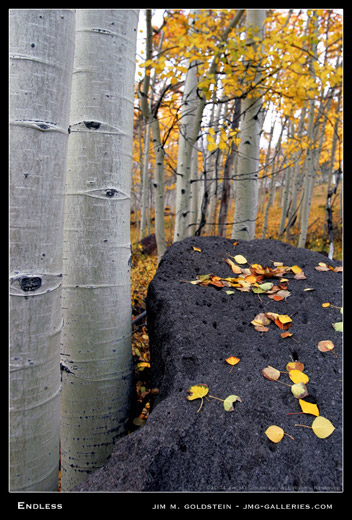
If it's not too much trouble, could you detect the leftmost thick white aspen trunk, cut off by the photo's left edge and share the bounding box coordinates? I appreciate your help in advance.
[9,9,75,491]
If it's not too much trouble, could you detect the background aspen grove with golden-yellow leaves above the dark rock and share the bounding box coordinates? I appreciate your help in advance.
[132,9,343,254]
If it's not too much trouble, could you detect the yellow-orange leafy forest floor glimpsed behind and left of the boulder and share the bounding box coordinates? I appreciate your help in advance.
[131,184,343,427]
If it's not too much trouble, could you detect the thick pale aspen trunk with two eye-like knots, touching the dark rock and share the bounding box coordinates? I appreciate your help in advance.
[61,9,138,490]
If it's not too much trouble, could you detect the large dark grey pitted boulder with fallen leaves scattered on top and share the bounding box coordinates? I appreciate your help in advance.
[75,237,342,492]
